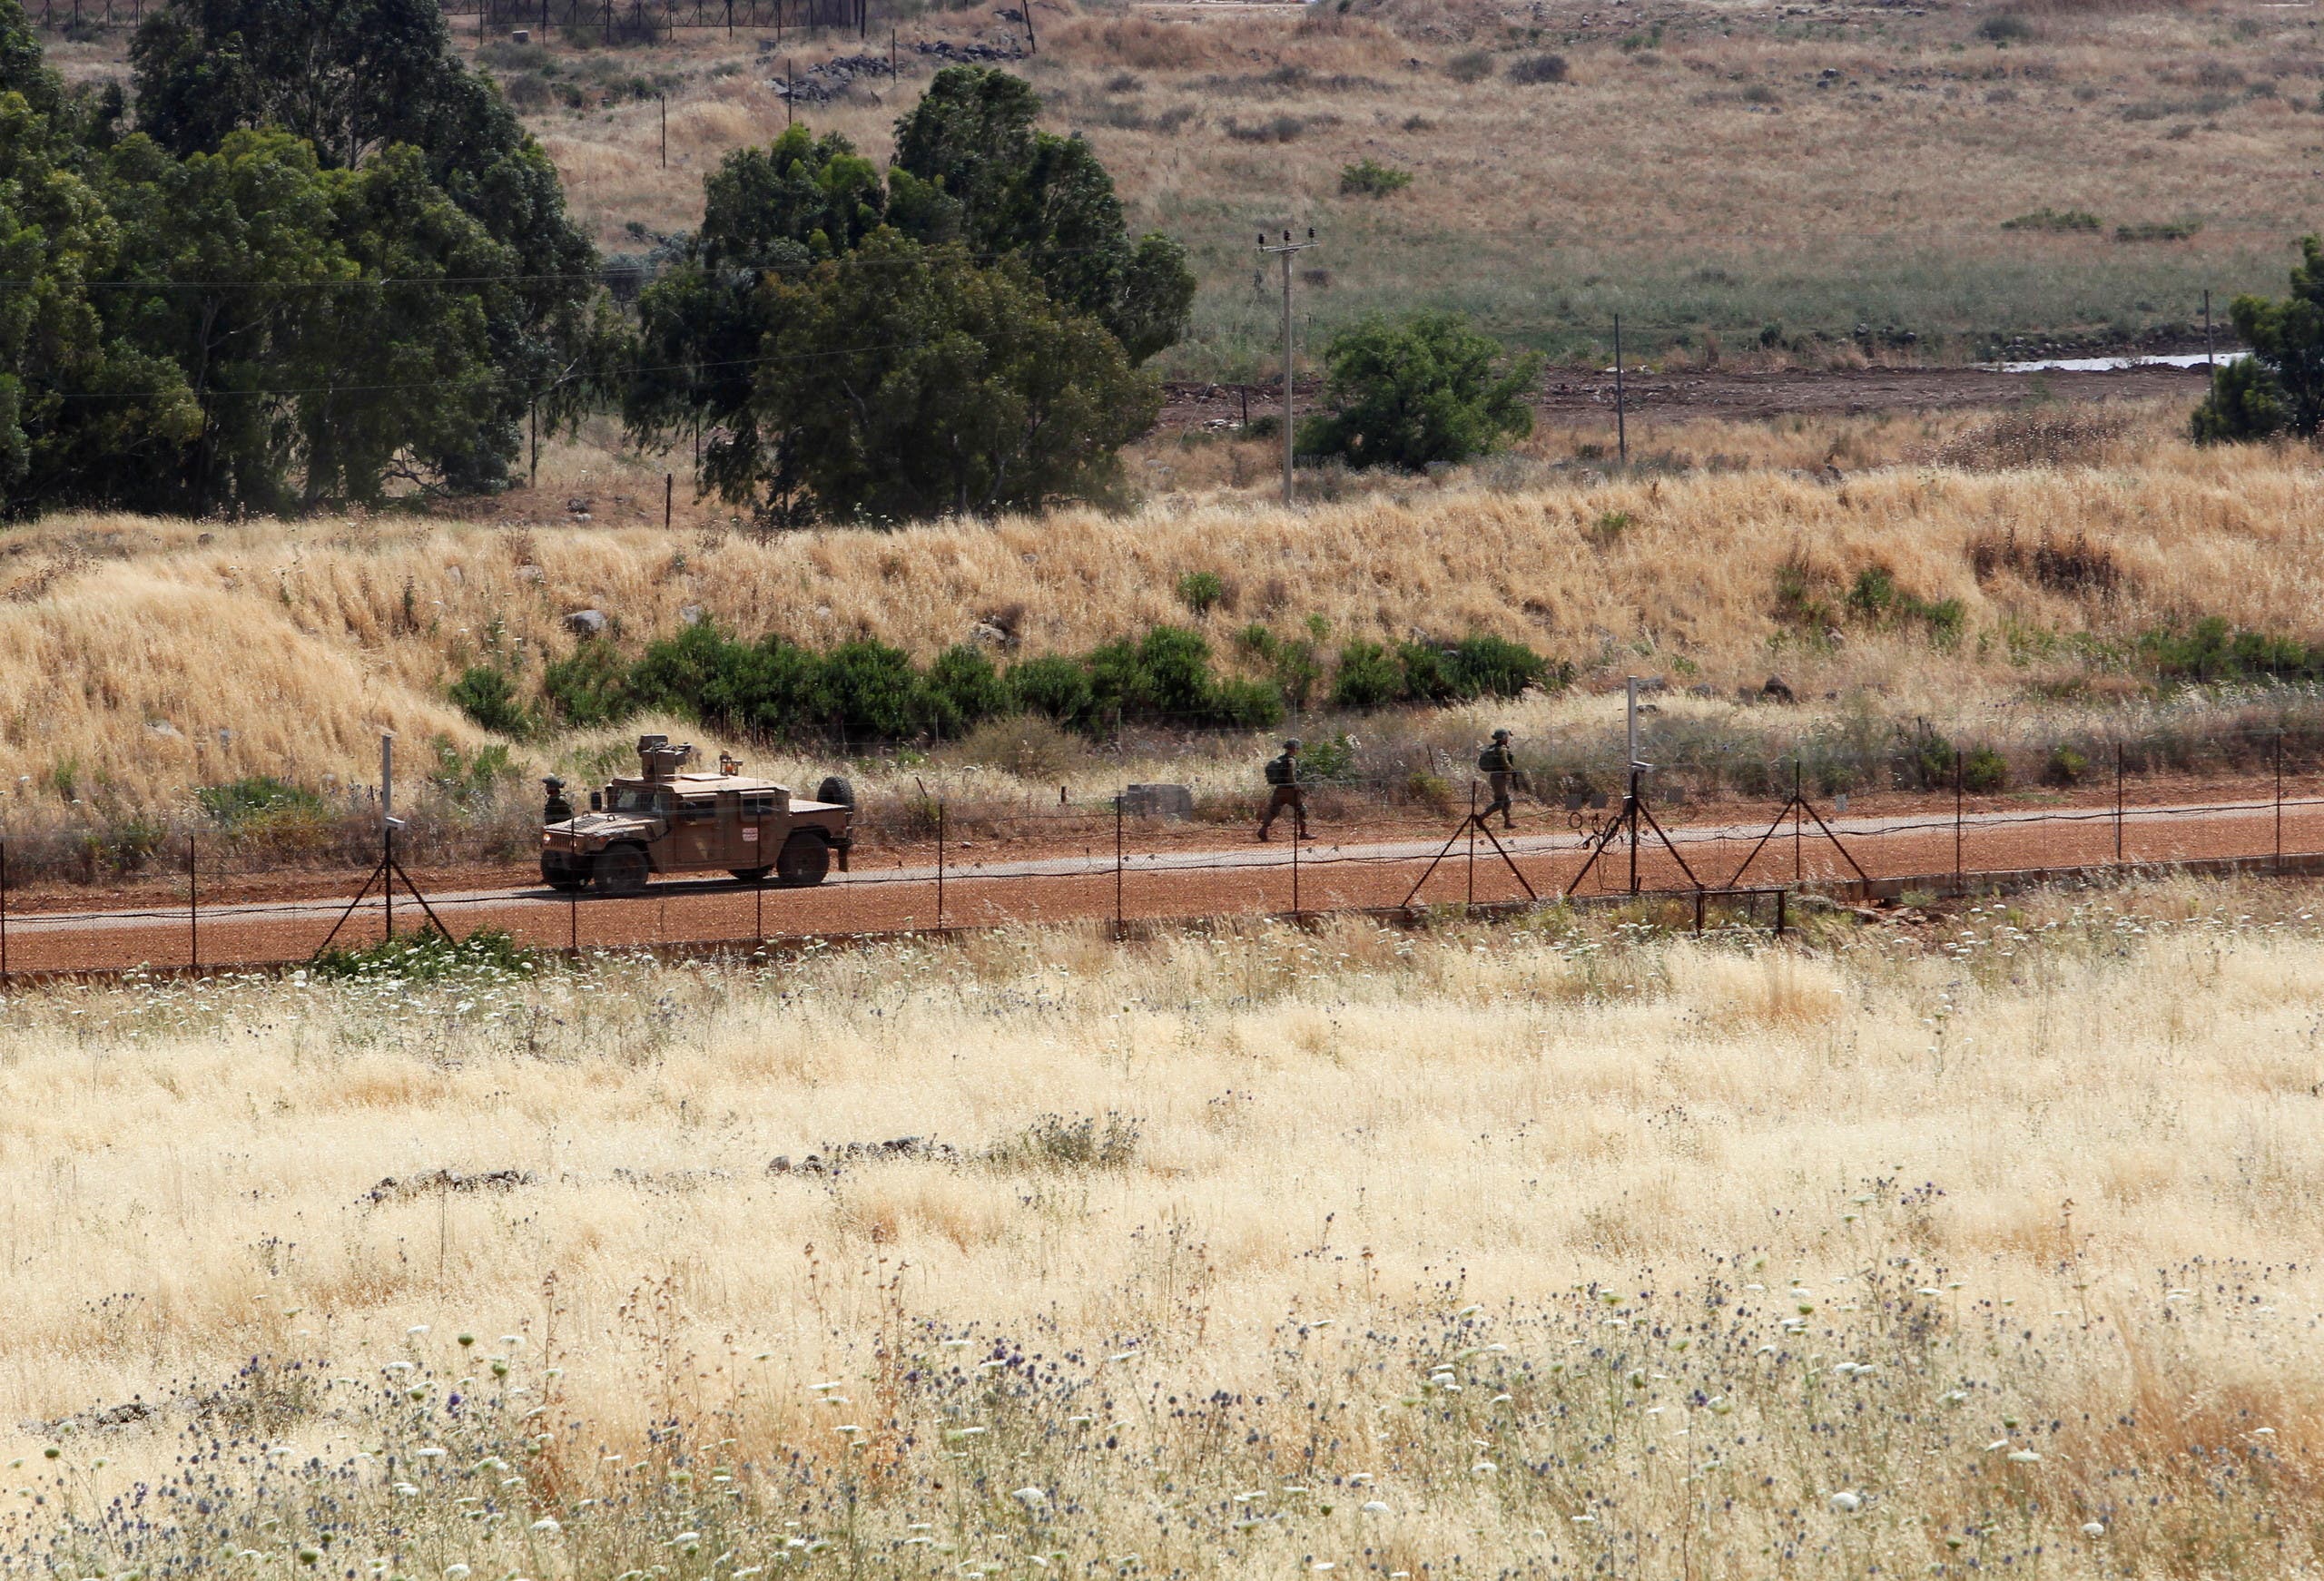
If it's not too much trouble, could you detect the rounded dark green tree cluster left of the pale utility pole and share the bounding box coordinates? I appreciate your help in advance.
[625,65,1195,521]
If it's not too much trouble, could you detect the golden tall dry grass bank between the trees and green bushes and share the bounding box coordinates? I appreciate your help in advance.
[0,402,2324,802]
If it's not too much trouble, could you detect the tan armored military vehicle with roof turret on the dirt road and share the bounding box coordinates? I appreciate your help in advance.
[541,735,855,895]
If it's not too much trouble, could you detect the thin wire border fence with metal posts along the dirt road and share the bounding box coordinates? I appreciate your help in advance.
[0,735,2324,986]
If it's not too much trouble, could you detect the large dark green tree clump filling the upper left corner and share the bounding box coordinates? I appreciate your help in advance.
[0,0,618,514]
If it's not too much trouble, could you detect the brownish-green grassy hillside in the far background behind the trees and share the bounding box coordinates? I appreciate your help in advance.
[32,0,2324,377]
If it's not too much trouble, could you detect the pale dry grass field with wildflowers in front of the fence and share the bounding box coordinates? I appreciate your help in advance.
[0,883,2324,1581]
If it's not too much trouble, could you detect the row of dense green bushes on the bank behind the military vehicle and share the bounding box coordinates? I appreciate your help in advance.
[451,621,1571,741]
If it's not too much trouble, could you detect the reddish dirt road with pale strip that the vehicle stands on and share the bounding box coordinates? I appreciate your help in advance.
[5,783,2324,972]
